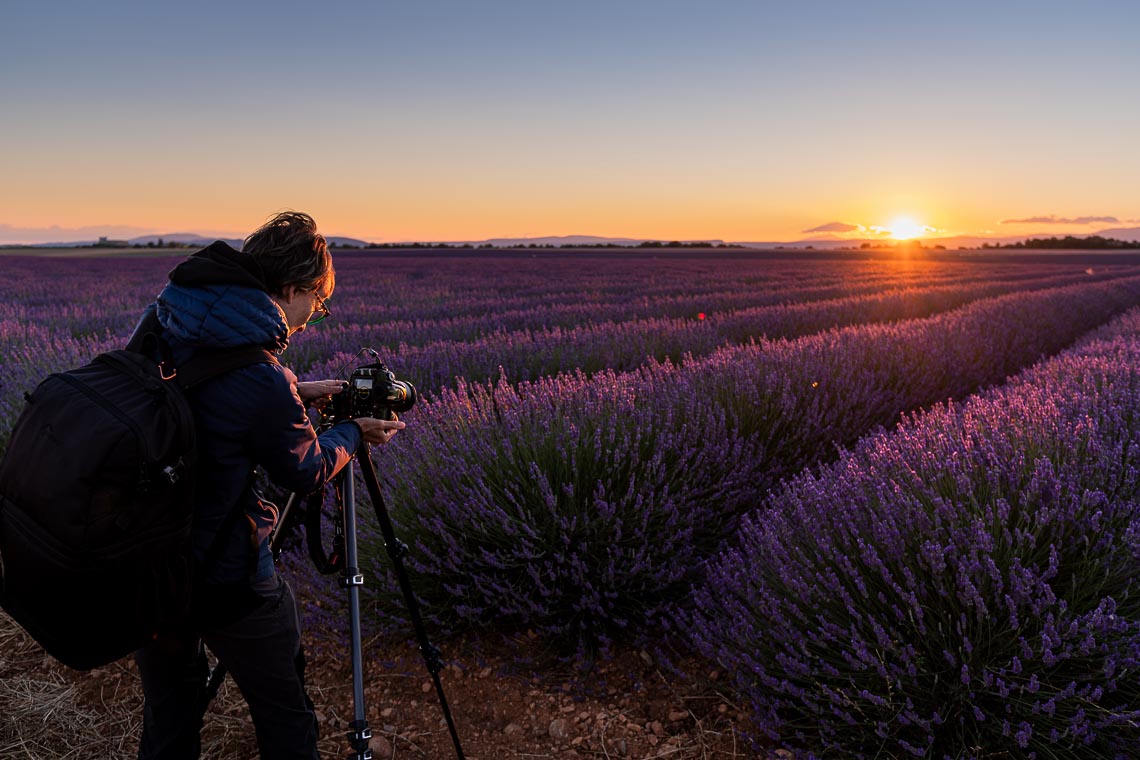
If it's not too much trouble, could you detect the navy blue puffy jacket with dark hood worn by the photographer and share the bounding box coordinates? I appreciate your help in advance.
[128,242,361,586]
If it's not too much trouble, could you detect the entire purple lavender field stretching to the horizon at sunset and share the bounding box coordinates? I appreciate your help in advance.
[0,252,1140,758]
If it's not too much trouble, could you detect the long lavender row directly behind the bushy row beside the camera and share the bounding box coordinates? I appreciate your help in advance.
[292,267,1116,391]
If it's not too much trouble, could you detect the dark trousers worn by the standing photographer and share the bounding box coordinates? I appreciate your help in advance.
[135,575,319,760]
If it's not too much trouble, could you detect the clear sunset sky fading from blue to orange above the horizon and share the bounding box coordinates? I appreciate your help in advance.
[0,0,1140,243]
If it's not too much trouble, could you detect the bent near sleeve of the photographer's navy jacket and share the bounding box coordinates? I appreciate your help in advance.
[247,365,361,493]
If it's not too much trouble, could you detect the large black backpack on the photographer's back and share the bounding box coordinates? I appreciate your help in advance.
[0,338,276,670]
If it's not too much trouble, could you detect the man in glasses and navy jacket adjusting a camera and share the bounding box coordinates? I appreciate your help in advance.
[132,212,404,760]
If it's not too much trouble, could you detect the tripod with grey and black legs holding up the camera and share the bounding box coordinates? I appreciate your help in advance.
[203,443,464,760]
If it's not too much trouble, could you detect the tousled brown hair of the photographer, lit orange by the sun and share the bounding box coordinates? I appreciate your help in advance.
[242,211,336,297]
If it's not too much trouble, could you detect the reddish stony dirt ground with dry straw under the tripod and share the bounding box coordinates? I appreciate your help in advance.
[0,613,764,760]
